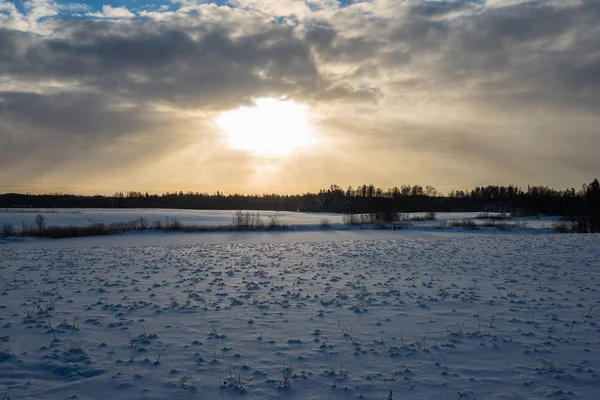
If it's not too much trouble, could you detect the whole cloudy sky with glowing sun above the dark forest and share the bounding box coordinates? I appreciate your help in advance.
[0,0,600,194]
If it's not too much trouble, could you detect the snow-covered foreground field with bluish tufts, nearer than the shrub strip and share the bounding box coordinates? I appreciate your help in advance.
[0,230,600,400]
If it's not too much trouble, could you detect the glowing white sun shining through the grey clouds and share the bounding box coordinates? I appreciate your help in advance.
[216,98,313,156]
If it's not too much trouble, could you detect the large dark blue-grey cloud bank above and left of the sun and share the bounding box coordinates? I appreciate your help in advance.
[0,13,350,109]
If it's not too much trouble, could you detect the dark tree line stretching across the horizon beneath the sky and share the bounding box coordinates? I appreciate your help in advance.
[0,179,600,225]
